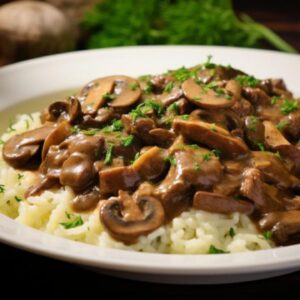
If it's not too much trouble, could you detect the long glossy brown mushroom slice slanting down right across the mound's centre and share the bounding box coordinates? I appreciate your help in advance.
[173,119,248,158]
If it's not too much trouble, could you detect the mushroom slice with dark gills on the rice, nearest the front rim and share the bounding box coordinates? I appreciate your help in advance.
[100,191,165,244]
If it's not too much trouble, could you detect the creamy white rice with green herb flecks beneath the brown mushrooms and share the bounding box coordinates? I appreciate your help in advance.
[0,113,273,254]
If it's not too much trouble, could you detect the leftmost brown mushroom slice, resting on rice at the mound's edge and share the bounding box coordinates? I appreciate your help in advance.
[3,126,53,168]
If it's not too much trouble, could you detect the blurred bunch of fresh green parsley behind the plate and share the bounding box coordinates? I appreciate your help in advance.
[82,0,296,52]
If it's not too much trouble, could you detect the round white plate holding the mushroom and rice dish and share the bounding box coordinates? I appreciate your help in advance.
[0,46,300,284]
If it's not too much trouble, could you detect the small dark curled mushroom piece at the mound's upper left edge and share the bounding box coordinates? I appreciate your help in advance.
[48,97,82,124]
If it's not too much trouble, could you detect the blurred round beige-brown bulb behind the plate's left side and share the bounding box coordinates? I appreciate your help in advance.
[0,1,75,63]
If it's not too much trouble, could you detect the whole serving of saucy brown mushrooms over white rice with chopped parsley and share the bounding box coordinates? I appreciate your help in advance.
[0,57,300,254]
